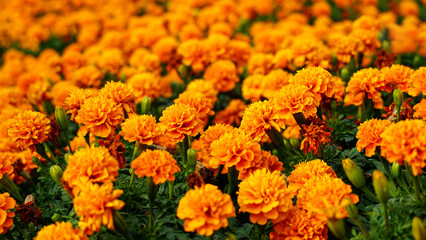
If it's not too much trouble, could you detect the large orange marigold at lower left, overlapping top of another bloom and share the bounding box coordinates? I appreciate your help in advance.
[63,145,119,195]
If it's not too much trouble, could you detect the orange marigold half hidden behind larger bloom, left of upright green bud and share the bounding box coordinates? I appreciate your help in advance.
[99,82,136,115]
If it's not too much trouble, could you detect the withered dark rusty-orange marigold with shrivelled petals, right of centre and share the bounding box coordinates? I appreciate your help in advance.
[300,117,333,154]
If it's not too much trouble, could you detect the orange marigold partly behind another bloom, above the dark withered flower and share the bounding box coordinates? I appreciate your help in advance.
[290,67,334,101]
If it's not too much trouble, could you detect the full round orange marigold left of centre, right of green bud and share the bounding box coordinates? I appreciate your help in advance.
[160,104,203,142]
